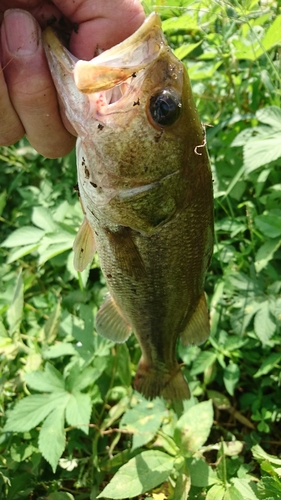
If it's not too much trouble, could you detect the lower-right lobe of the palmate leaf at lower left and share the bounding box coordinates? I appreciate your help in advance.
[65,391,92,434]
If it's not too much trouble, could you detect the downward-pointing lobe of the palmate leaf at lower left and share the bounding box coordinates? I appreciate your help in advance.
[39,406,65,473]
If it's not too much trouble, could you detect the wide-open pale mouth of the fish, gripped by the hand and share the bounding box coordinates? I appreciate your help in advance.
[43,13,167,115]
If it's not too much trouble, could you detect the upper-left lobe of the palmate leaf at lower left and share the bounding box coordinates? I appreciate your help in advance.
[24,363,65,393]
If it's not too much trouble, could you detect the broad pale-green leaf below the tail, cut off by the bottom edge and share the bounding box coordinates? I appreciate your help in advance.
[97,450,175,499]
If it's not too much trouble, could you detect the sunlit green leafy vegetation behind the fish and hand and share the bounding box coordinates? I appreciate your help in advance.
[0,0,281,500]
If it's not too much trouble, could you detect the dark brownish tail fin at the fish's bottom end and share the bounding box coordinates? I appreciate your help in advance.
[135,358,190,401]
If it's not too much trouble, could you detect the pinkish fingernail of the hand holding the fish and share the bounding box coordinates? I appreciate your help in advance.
[3,9,39,56]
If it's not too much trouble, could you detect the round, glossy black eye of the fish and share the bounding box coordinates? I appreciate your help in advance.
[149,90,182,127]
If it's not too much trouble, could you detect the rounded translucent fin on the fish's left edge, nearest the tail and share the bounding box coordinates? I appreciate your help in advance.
[96,294,132,343]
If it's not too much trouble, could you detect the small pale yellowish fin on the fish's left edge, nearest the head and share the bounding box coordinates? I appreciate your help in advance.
[73,217,96,272]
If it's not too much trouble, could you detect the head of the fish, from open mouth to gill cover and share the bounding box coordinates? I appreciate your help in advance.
[44,13,208,234]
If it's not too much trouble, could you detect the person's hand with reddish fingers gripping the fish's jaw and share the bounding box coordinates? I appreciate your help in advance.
[0,0,145,158]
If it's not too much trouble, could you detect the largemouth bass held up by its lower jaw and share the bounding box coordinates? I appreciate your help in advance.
[44,13,213,400]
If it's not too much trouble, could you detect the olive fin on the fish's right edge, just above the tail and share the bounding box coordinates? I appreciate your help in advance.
[180,292,210,345]
